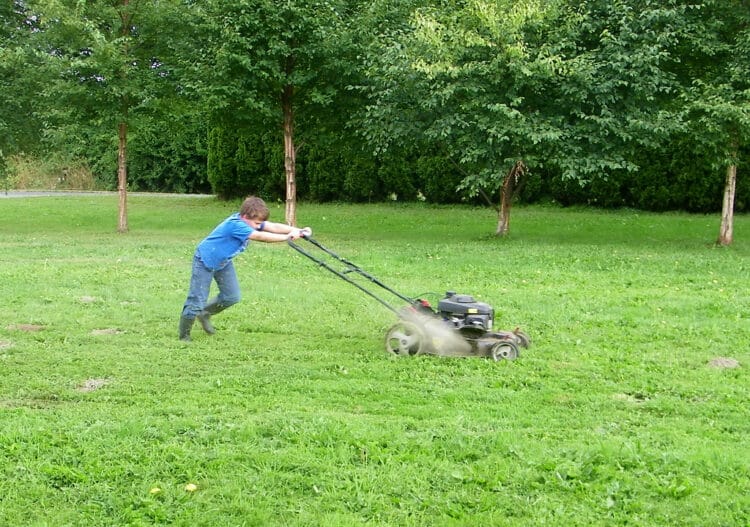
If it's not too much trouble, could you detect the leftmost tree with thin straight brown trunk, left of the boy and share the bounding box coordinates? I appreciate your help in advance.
[28,0,185,232]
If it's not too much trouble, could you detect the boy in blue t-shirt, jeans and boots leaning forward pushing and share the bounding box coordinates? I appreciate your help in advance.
[179,196,312,341]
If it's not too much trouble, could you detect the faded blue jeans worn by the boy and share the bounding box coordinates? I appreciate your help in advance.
[182,252,242,319]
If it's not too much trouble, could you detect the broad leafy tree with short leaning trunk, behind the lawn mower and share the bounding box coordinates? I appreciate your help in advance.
[365,0,688,235]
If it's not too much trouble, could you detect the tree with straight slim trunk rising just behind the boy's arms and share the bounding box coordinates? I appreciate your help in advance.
[192,0,360,225]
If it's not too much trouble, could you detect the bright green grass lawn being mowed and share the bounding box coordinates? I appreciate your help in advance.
[0,196,750,526]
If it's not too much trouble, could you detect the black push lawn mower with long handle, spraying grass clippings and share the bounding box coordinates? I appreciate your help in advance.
[288,236,531,361]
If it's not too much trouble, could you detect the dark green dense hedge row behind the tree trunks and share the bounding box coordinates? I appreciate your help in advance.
[208,127,750,213]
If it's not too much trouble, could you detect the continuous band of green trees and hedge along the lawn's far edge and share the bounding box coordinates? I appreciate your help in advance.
[0,0,750,212]
